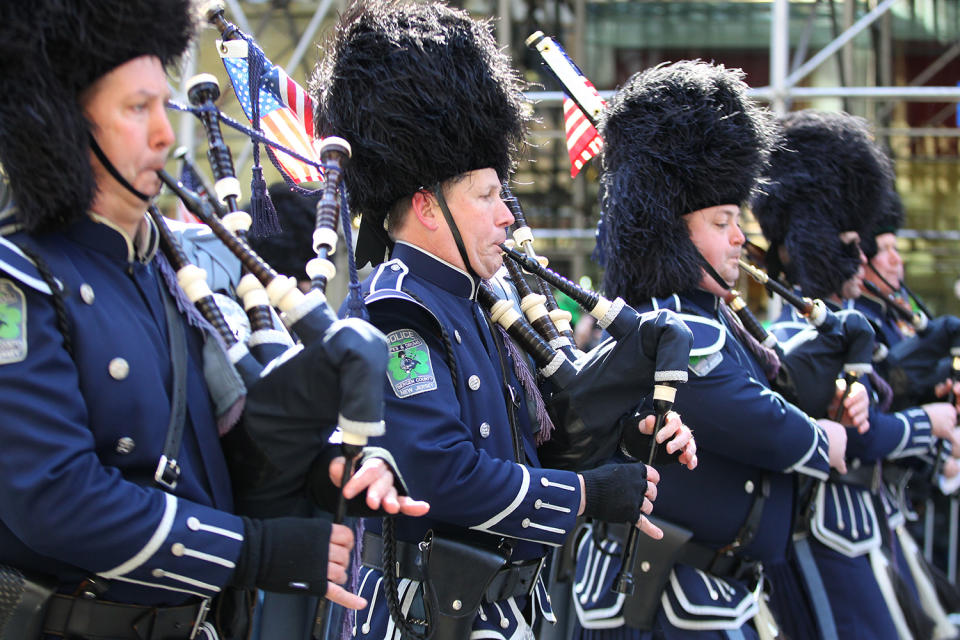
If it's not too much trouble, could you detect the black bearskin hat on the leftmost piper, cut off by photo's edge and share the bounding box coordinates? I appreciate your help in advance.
[0,0,193,231]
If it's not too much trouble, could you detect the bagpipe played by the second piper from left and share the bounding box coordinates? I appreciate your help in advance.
[477,185,693,594]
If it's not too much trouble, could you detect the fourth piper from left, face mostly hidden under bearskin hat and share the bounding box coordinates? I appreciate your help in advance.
[753,111,957,638]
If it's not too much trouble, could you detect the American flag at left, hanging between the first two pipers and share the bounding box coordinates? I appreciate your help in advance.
[218,40,323,184]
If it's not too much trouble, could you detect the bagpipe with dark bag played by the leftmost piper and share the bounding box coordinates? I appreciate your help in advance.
[152,0,387,560]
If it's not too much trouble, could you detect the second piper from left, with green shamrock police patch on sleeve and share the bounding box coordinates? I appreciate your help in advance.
[314,2,694,640]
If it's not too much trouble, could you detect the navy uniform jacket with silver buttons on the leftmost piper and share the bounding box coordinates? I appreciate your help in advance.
[0,217,243,604]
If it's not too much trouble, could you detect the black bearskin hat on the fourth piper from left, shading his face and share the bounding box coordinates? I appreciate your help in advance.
[753,110,893,297]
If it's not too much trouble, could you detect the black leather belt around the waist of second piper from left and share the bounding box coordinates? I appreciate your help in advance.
[360,531,544,602]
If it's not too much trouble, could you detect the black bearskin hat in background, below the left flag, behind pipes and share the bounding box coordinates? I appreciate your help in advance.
[246,182,317,280]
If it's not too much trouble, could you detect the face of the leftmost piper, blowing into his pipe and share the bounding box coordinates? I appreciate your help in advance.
[80,56,174,222]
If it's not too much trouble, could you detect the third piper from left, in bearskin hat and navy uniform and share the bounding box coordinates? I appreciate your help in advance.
[573,62,866,638]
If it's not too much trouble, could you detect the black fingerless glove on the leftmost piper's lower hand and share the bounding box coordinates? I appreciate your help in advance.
[230,518,331,596]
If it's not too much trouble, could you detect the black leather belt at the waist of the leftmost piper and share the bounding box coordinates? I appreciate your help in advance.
[43,594,209,640]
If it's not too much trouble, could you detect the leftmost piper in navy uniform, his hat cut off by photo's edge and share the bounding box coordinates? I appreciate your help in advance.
[0,0,425,640]
